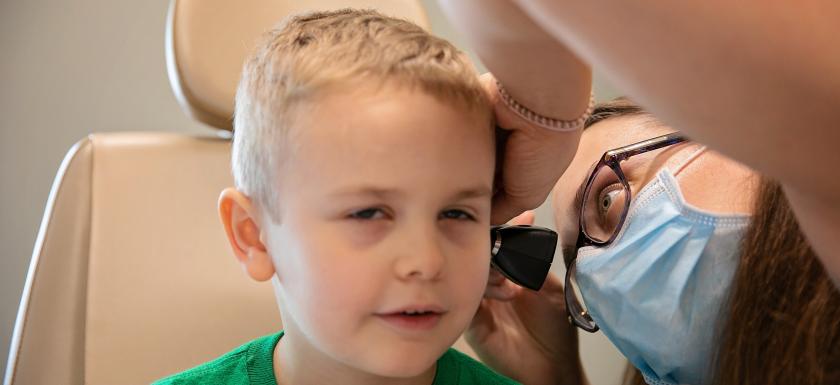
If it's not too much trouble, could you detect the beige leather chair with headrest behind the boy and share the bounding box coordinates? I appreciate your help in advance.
[4,0,460,385]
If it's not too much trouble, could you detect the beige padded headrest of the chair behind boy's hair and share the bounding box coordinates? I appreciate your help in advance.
[166,0,429,130]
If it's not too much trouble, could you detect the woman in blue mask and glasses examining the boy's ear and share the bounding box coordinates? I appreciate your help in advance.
[426,0,840,384]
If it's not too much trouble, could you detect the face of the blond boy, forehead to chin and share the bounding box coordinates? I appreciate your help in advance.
[262,86,494,377]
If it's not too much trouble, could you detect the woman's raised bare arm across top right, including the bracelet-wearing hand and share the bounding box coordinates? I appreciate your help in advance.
[441,0,840,283]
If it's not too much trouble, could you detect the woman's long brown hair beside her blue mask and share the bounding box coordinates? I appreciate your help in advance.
[586,98,840,385]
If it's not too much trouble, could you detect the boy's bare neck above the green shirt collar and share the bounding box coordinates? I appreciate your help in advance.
[272,329,437,385]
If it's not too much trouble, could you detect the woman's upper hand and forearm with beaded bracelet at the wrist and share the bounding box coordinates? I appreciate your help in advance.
[439,0,592,224]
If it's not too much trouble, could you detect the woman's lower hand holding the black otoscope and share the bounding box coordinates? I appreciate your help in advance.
[465,212,585,385]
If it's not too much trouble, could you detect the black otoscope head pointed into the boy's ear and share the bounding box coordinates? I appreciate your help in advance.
[490,225,557,290]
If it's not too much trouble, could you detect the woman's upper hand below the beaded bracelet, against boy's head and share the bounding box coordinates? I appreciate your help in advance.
[481,73,581,224]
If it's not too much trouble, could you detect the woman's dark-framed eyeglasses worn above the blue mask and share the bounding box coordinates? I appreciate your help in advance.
[564,133,688,333]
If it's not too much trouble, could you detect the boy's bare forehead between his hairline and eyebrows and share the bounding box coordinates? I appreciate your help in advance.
[284,89,495,187]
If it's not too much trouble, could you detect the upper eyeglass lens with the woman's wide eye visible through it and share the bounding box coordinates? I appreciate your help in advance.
[581,165,628,242]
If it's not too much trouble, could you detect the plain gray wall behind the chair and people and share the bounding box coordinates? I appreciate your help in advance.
[0,0,623,384]
